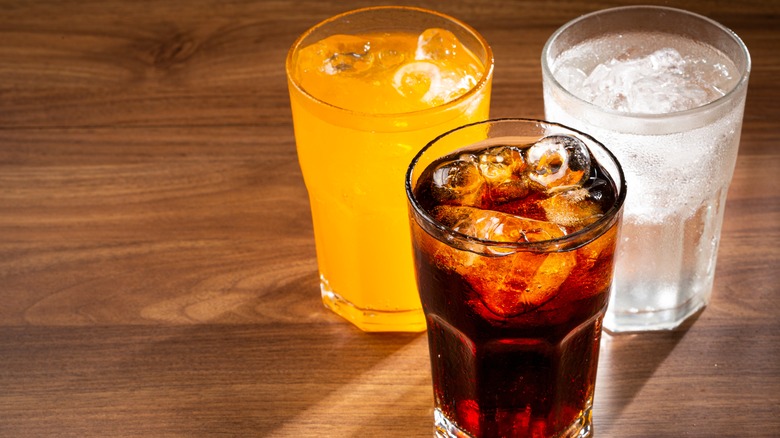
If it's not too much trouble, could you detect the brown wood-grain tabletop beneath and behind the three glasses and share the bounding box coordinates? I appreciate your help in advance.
[0,0,780,437]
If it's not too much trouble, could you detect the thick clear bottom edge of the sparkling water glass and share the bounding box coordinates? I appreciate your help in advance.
[604,292,709,333]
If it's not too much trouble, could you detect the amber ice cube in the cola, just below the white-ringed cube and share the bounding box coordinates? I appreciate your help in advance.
[539,188,603,229]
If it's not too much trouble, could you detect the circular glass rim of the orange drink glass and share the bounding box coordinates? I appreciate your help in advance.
[285,6,495,119]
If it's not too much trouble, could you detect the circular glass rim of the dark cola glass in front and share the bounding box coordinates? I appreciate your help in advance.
[404,117,627,252]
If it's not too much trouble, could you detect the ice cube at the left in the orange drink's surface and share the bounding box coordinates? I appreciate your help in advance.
[316,35,374,76]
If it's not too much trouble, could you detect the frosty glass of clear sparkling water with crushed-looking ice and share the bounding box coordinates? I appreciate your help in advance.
[542,6,750,332]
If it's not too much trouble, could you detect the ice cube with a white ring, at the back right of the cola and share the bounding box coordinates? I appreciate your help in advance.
[526,135,590,192]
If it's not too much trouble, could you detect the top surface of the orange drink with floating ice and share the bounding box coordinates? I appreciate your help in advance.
[297,28,484,114]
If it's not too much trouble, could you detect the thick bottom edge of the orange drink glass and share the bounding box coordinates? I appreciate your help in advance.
[320,276,425,332]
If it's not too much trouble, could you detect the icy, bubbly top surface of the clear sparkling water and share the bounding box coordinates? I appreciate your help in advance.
[553,32,740,114]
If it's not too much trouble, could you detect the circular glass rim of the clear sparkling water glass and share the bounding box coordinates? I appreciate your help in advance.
[542,5,752,120]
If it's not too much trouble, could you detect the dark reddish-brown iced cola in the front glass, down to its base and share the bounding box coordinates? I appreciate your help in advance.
[410,120,622,437]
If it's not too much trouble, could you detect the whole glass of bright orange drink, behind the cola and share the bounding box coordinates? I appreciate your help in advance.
[287,7,493,331]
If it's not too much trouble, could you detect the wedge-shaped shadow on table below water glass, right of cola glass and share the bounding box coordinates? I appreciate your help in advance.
[594,312,701,436]
